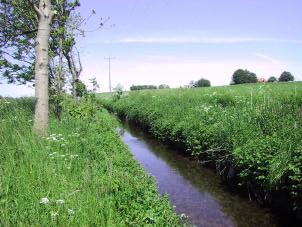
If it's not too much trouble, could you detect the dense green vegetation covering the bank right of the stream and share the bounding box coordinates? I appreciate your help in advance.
[103,83,302,219]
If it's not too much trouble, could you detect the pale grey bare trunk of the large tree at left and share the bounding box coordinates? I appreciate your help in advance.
[34,0,54,135]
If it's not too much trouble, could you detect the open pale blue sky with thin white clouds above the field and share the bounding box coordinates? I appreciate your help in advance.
[0,0,302,93]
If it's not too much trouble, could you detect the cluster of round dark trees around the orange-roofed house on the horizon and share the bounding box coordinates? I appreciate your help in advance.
[231,69,295,85]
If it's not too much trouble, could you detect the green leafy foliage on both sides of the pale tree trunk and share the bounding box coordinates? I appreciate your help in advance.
[0,0,79,83]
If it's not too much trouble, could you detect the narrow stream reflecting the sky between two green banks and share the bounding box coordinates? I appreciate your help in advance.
[120,119,275,227]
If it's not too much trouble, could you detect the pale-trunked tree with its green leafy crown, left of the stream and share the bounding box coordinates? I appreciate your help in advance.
[0,0,84,135]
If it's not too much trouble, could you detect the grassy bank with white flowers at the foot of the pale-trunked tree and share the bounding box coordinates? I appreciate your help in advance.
[0,99,179,226]
